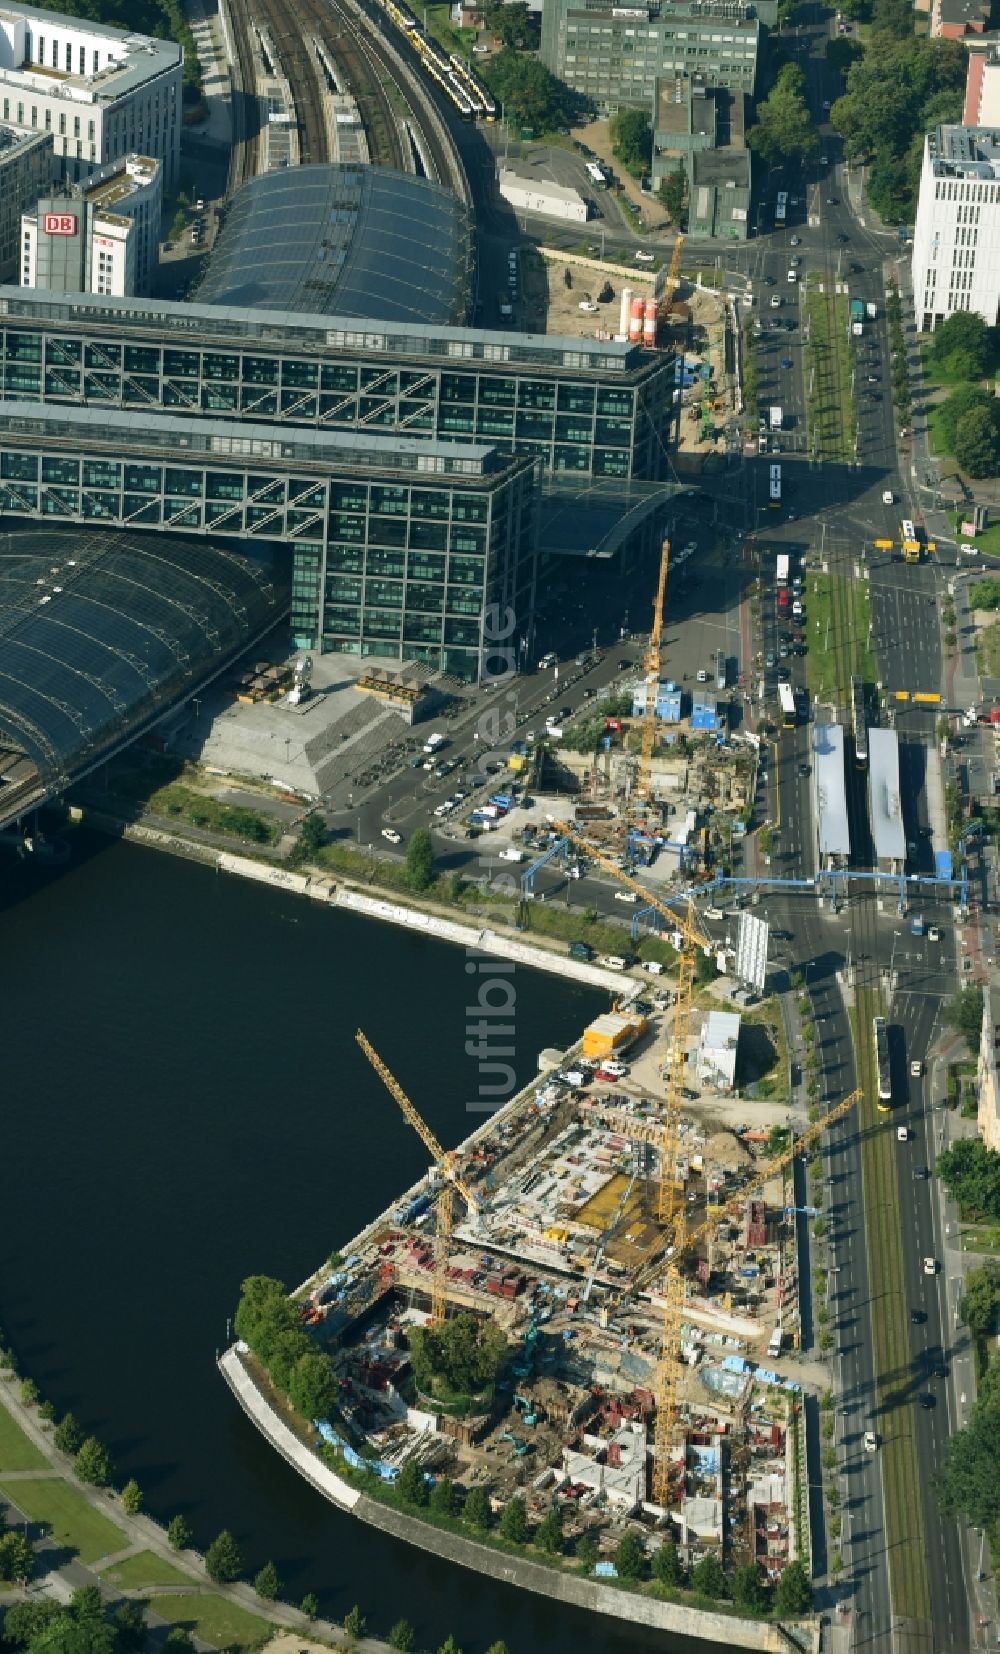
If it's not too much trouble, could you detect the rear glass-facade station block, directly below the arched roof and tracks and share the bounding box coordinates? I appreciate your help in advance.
[0,288,674,480]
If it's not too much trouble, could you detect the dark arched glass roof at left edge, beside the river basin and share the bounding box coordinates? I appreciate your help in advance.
[0,529,286,787]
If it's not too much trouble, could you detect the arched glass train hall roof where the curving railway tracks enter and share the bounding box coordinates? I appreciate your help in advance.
[197,165,471,326]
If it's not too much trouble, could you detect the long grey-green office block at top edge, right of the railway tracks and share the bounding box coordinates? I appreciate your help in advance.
[542,0,760,114]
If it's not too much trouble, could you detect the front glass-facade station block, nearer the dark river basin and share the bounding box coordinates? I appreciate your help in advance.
[0,402,539,680]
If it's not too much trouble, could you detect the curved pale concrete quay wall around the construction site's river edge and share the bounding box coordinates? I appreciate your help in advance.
[218,1345,809,1654]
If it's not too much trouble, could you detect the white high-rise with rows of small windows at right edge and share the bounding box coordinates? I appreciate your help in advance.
[912,126,1000,332]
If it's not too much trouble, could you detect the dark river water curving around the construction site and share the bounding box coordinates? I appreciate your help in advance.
[0,835,717,1654]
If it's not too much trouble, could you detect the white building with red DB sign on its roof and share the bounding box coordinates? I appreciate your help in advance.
[20,155,164,298]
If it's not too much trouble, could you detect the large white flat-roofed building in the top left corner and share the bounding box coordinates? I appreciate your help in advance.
[0,5,182,189]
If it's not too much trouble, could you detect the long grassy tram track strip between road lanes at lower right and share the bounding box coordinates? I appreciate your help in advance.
[851,987,931,1621]
